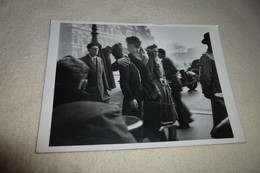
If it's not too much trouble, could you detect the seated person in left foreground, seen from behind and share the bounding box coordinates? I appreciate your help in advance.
[49,56,136,146]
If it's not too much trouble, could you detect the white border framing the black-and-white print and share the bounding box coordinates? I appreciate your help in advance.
[36,20,245,153]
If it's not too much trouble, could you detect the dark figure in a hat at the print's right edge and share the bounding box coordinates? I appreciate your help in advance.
[199,32,232,137]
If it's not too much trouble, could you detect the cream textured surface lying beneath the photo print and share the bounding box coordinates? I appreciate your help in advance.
[0,0,260,173]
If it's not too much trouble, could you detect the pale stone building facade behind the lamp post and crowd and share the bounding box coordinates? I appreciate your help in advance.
[58,23,154,59]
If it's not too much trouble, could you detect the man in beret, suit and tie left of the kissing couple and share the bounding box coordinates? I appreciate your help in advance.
[80,43,110,103]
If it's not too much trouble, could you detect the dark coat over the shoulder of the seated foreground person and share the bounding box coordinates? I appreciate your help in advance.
[49,101,136,146]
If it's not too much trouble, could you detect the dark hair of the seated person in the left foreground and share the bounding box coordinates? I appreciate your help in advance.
[56,55,89,88]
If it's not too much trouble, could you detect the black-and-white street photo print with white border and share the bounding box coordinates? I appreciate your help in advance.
[36,20,245,153]
